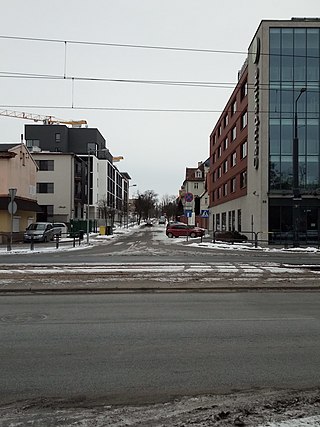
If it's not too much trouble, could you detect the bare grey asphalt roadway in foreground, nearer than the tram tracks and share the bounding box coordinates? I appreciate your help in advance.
[0,292,320,404]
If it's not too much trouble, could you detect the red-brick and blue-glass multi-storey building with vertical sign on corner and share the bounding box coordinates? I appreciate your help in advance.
[209,18,320,244]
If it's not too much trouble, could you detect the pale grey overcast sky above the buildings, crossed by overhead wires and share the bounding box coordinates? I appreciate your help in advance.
[0,0,320,198]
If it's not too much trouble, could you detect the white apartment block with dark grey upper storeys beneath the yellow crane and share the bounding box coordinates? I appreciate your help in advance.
[25,125,130,226]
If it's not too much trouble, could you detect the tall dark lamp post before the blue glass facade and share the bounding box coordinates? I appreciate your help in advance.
[292,87,306,246]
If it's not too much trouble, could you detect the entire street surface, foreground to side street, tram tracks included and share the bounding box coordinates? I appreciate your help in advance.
[0,225,320,426]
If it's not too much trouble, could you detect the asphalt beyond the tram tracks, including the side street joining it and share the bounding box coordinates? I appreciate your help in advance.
[0,225,320,265]
